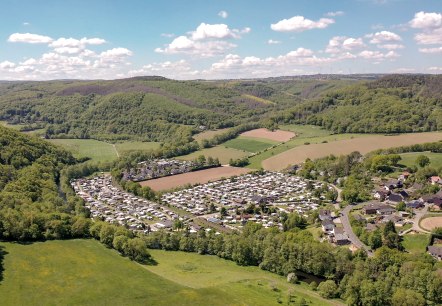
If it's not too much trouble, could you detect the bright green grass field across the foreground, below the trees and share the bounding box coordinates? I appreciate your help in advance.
[0,240,340,306]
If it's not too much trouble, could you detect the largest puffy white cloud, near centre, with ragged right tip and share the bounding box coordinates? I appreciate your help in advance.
[155,23,247,57]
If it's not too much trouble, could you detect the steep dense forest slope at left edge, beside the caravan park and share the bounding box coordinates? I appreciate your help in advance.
[0,126,84,241]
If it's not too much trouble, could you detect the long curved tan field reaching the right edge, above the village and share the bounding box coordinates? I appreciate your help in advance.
[262,132,442,170]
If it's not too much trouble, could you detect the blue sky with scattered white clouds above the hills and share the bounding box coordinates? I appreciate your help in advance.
[0,0,442,80]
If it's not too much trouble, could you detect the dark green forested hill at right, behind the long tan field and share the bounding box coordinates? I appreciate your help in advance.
[277,75,442,133]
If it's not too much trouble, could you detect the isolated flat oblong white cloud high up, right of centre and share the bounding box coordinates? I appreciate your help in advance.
[270,16,335,32]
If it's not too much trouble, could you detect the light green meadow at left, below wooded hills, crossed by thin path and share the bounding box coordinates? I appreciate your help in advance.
[49,139,118,162]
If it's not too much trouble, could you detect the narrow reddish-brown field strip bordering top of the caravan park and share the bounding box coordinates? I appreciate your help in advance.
[140,166,250,191]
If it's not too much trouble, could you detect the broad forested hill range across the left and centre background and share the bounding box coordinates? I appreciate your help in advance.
[0,77,359,144]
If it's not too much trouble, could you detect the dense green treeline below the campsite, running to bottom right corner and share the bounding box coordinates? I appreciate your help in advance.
[143,223,442,306]
